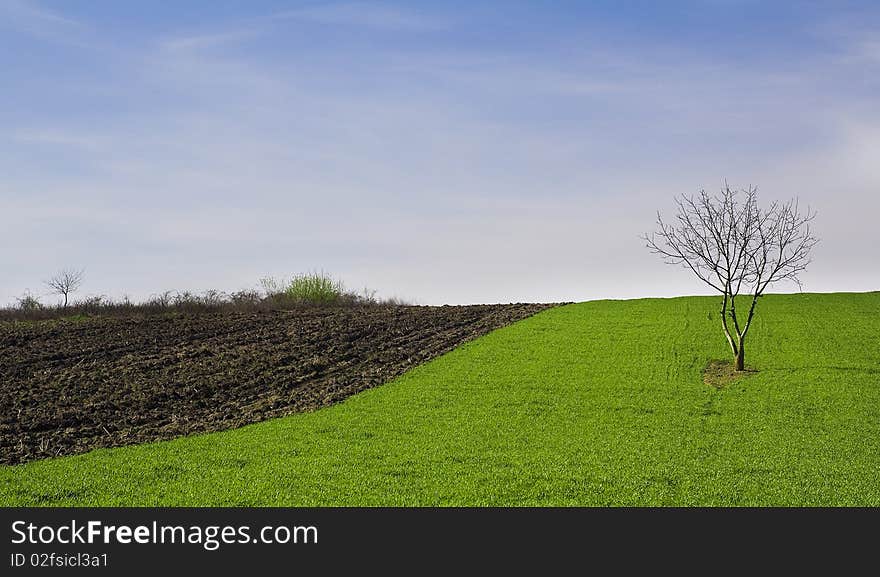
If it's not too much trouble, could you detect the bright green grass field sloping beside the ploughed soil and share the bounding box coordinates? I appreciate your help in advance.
[0,293,880,506]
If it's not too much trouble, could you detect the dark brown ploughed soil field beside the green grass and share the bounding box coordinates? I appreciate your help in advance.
[0,304,551,464]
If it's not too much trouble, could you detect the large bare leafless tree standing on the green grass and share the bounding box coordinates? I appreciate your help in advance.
[643,183,818,371]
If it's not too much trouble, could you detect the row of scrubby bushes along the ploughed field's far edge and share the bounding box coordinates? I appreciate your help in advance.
[0,273,407,320]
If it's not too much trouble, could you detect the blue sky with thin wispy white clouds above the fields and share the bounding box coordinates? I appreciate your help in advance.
[0,0,880,305]
